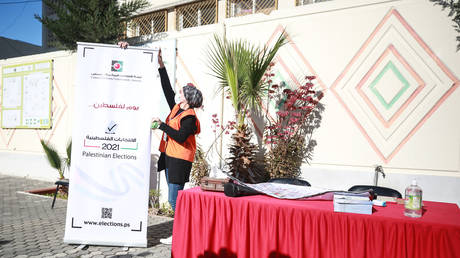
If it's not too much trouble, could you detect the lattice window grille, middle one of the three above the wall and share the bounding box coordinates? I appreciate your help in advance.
[176,0,217,30]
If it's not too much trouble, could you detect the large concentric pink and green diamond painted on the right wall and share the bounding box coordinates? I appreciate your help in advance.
[330,8,459,163]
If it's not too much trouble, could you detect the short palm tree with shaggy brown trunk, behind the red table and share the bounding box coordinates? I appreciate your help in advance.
[208,31,287,183]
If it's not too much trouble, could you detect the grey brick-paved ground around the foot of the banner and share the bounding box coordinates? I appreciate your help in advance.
[0,174,173,258]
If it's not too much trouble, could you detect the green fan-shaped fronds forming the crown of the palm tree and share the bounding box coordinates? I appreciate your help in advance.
[207,31,287,126]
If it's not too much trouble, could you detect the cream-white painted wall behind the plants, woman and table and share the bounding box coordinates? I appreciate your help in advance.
[0,0,460,206]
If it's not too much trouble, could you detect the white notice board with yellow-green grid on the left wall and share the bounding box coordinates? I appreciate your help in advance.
[1,60,53,128]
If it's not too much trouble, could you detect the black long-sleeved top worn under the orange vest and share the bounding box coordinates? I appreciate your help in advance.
[158,68,197,184]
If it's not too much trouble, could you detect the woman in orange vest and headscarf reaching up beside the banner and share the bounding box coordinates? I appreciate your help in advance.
[153,49,203,216]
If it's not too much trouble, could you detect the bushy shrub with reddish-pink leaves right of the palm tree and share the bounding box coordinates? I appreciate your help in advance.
[265,73,324,178]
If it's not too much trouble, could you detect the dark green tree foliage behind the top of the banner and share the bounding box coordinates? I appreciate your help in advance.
[35,0,149,50]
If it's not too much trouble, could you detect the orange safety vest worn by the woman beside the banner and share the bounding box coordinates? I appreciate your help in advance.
[160,104,200,162]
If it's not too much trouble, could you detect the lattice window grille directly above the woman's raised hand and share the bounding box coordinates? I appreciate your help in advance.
[128,10,168,37]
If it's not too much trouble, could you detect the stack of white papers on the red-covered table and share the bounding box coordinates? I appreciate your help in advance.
[334,192,372,214]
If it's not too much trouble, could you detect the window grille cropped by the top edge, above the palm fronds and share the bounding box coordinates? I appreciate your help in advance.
[227,0,278,18]
